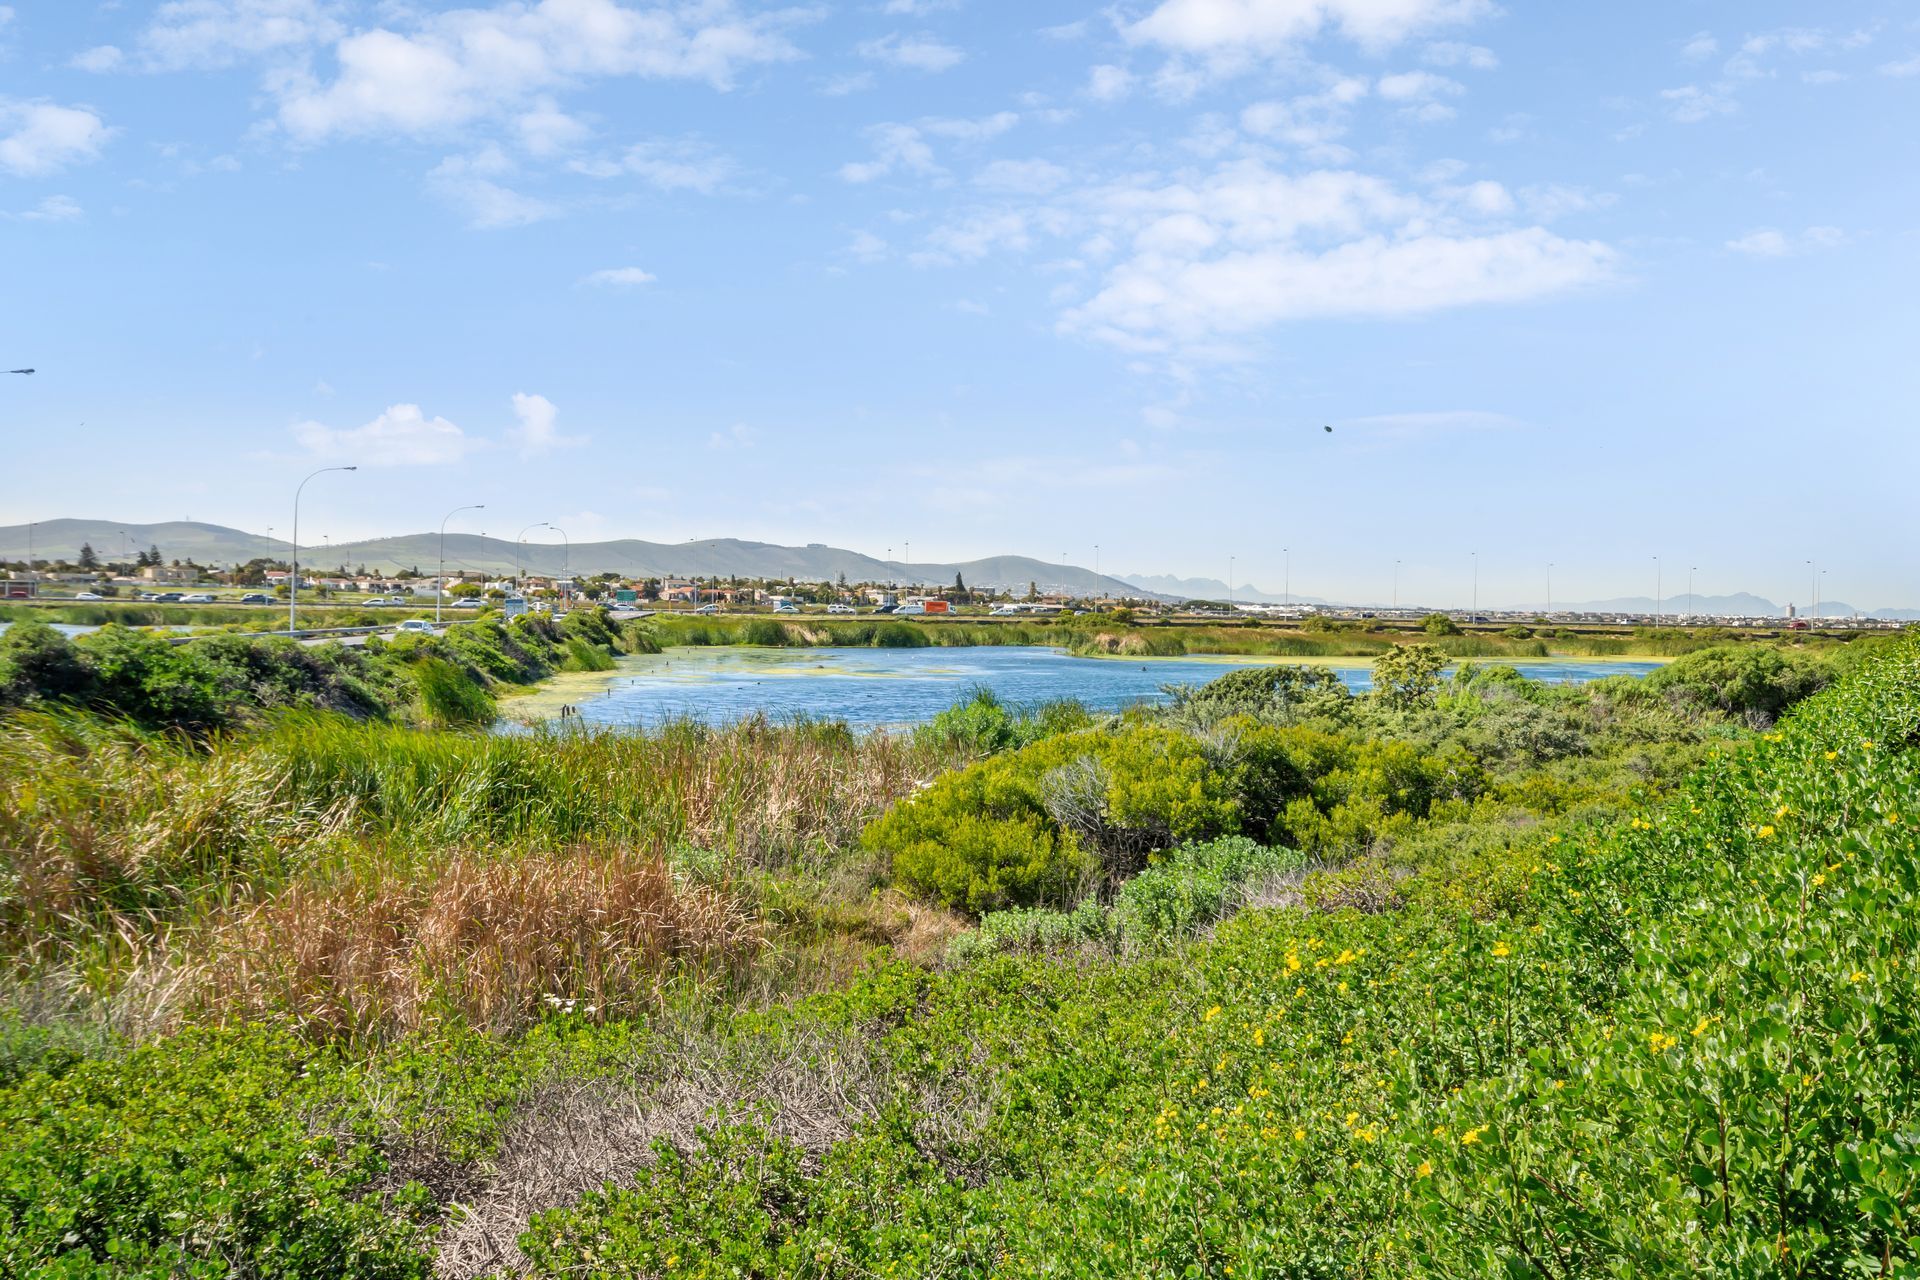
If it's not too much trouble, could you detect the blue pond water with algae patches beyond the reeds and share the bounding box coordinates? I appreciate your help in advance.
[529,645,1659,727]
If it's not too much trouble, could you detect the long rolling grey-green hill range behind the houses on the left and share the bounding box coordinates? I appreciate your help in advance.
[0,520,1140,597]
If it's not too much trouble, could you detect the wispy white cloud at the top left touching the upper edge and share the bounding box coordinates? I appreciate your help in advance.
[269,0,806,142]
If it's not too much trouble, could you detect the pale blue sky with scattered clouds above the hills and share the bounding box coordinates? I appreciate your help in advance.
[0,0,1920,608]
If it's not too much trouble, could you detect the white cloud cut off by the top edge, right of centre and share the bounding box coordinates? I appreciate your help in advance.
[1121,0,1496,56]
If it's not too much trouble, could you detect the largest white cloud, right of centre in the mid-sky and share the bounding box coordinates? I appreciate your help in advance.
[912,159,1617,359]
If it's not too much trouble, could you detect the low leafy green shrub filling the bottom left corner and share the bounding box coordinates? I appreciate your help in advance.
[0,1029,430,1280]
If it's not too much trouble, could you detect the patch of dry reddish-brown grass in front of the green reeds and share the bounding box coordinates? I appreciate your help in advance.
[192,848,762,1038]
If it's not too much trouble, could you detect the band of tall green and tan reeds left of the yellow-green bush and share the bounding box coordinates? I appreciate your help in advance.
[0,714,956,952]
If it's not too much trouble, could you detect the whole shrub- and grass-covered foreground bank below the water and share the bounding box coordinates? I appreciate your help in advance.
[0,639,1920,1278]
